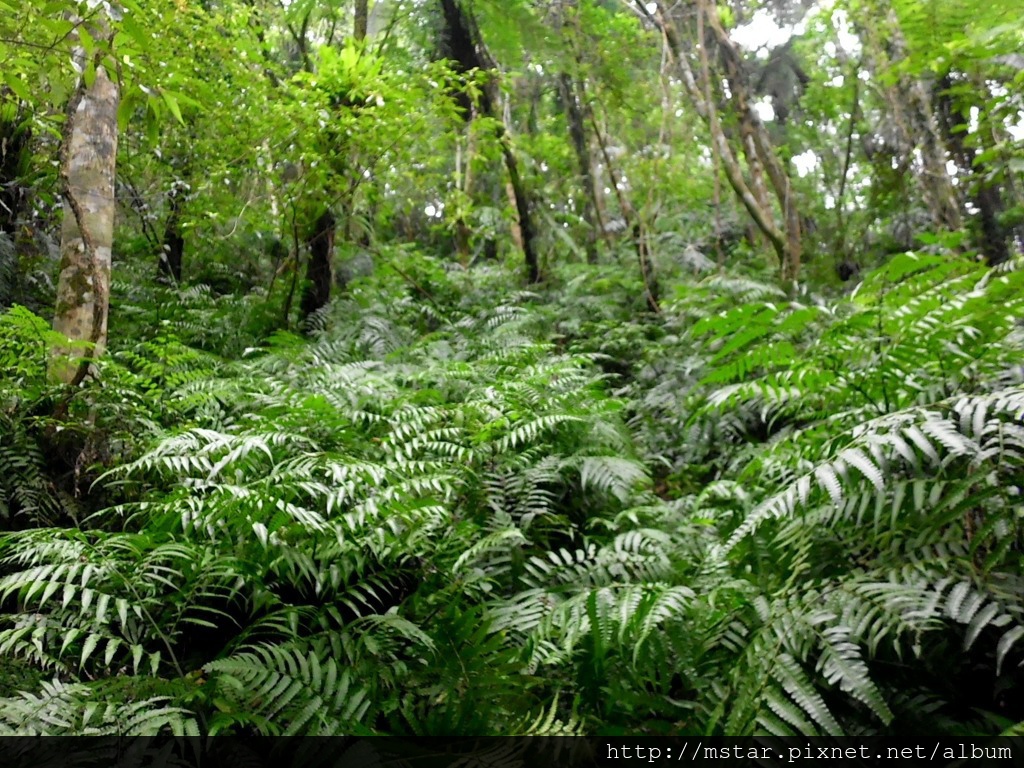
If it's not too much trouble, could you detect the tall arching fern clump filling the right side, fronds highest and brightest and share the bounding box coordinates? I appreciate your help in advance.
[638,254,1024,734]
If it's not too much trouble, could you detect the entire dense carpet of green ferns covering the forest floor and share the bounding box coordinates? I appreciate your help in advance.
[0,247,1024,735]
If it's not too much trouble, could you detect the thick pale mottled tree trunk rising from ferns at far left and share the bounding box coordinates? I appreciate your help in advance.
[50,67,120,385]
